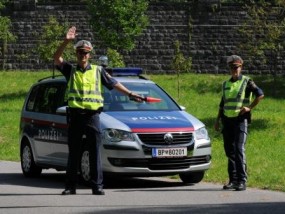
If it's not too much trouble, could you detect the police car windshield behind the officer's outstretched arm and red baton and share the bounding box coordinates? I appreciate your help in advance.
[103,82,180,111]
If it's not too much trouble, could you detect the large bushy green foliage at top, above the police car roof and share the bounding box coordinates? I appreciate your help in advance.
[87,0,148,51]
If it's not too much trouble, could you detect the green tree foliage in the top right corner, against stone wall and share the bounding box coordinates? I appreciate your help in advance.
[236,1,285,66]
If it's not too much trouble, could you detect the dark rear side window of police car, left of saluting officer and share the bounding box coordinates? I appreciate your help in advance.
[26,83,66,114]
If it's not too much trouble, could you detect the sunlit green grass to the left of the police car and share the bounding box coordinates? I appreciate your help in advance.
[0,72,51,161]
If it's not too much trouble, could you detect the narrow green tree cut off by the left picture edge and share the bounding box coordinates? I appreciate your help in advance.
[0,0,17,69]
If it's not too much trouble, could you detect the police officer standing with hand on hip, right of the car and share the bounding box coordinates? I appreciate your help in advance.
[215,55,264,191]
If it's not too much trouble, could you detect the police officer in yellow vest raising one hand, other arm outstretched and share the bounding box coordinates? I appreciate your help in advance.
[54,26,143,195]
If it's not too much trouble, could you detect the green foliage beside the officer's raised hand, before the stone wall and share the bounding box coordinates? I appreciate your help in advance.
[37,16,74,62]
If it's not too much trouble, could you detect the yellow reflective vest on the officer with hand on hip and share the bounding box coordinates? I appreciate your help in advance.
[223,76,251,117]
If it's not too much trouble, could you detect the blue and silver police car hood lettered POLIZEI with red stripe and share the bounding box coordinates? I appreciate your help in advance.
[101,111,203,133]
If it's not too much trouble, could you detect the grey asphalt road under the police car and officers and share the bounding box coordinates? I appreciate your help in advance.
[0,161,285,214]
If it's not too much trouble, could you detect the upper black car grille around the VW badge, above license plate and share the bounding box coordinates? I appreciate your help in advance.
[137,132,193,145]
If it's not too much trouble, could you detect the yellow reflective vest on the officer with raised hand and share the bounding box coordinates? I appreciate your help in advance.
[68,65,103,110]
